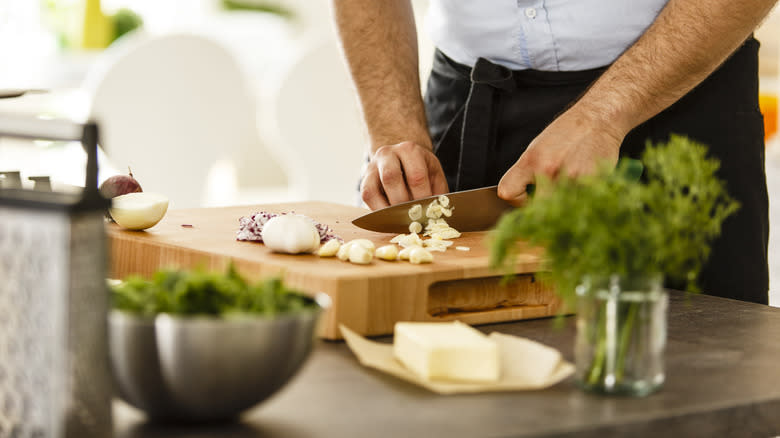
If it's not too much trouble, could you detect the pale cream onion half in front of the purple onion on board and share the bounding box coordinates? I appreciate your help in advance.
[108,192,168,230]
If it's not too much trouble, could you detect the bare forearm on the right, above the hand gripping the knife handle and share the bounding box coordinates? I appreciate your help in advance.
[571,0,776,138]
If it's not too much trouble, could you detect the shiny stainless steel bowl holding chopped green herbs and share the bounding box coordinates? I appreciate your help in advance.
[109,294,330,421]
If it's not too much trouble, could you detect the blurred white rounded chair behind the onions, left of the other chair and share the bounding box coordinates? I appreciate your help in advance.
[85,34,285,208]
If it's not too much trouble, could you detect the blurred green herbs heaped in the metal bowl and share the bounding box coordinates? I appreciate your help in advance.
[111,264,317,316]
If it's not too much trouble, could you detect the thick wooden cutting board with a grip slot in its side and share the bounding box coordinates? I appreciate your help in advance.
[108,202,560,339]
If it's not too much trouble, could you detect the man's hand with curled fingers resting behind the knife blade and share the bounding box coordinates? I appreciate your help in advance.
[360,141,449,210]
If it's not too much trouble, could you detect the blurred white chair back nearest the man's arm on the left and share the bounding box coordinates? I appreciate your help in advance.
[258,33,368,205]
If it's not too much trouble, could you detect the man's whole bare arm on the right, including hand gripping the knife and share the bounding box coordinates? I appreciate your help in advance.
[498,0,777,204]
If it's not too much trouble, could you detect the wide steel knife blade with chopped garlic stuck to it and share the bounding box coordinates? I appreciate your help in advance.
[352,186,514,234]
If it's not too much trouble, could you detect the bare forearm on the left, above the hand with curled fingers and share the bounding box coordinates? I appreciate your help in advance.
[332,0,432,152]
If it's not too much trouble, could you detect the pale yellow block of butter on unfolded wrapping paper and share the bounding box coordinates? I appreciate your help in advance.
[393,321,500,382]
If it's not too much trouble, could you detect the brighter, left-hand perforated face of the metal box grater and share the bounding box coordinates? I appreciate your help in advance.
[0,209,70,438]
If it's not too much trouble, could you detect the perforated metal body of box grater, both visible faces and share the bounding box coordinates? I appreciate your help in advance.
[0,206,112,438]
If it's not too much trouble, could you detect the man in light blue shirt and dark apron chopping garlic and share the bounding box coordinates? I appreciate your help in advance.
[333,0,775,303]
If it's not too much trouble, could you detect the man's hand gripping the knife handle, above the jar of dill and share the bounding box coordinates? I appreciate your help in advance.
[498,106,626,205]
